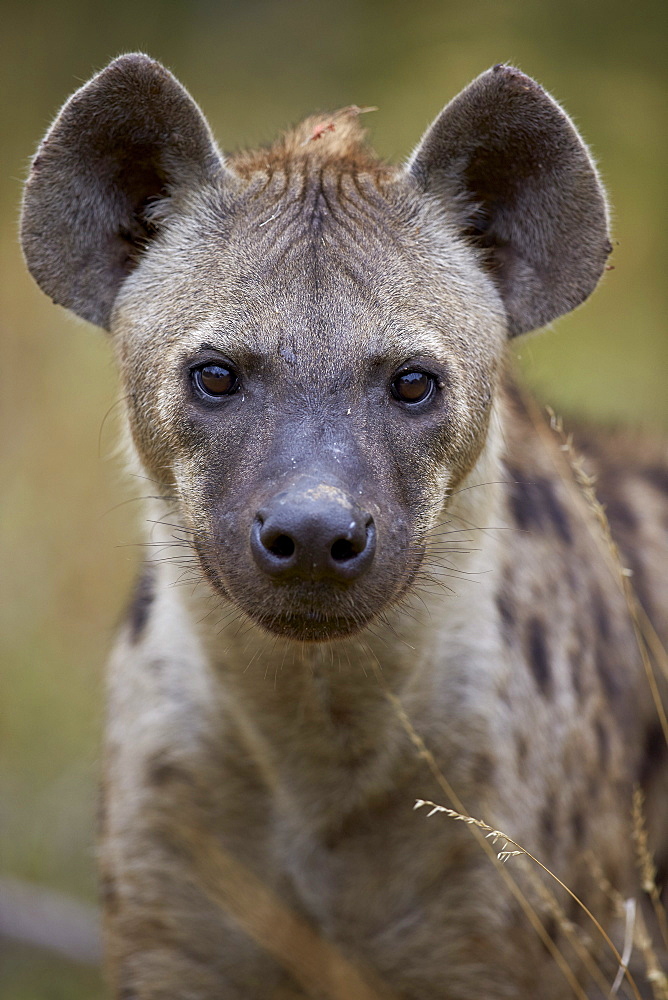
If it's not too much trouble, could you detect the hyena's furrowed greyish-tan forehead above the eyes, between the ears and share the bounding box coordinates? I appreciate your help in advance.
[116,156,501,361]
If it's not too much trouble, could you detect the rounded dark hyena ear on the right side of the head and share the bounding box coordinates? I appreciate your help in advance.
[407,66,612,336]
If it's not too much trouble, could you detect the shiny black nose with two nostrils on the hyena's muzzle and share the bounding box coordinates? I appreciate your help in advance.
[250,482,376,583]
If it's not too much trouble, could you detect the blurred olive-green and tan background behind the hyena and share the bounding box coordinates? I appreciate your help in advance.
[0,0,668,1000]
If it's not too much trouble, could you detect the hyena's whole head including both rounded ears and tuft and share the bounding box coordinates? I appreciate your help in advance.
[22,55,610,639]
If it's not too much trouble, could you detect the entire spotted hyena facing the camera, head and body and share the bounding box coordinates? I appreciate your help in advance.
[22,55,668,1000]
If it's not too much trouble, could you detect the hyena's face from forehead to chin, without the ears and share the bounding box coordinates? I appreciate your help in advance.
[114,157,503,638]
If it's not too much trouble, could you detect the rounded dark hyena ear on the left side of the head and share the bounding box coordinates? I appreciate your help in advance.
[21,54,223,329]
